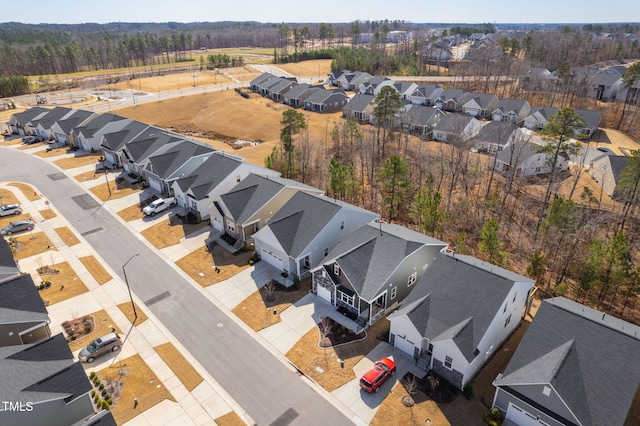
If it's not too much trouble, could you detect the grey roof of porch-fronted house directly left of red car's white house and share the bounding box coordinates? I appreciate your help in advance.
[328,223,447,301]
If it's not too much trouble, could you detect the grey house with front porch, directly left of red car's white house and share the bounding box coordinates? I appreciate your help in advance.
[311,223,447,328]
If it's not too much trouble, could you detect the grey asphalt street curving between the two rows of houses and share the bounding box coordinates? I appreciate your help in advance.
[0,147,351,425]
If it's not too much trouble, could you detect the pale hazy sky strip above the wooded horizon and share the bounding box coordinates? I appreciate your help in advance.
[0,0,640,24]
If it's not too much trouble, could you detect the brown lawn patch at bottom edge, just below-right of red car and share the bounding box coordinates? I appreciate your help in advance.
[370,383,450,426]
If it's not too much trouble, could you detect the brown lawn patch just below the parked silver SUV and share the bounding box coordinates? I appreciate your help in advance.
[98,354,175,425]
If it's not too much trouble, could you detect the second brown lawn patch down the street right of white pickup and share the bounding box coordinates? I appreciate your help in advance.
[176,245,253,287]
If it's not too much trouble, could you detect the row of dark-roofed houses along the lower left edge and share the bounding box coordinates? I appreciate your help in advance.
[0,238,116,426]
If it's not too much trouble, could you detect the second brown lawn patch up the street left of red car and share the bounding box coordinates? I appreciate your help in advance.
[231,278,311,331]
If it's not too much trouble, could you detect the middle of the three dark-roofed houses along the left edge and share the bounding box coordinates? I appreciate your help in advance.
[0,274,51,348]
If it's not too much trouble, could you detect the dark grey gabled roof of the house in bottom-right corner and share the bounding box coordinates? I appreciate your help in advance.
[496,297,640,425]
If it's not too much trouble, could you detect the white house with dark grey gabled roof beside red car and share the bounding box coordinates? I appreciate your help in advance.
[388,253,533,389]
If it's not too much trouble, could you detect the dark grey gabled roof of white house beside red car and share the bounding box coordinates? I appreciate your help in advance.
[390,253,533,362]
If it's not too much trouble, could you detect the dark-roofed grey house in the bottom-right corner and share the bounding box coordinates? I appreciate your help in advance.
[493,297,640,426]
